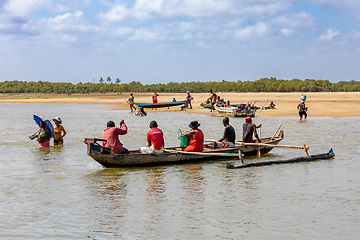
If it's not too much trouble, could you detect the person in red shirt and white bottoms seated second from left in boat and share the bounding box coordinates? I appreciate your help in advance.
[140,121,165,155]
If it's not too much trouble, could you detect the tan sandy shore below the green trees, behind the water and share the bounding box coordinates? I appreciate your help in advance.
[0,92,360,117]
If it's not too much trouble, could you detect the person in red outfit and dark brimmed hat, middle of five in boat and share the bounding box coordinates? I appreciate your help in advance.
[183,121,204,152]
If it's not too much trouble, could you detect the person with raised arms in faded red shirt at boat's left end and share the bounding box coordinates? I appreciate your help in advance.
[102,120,130,154]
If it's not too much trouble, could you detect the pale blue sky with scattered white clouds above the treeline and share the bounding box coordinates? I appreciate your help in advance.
[0,0,360,84]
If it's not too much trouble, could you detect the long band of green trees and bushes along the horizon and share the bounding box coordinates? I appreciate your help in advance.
[0,77,360,94]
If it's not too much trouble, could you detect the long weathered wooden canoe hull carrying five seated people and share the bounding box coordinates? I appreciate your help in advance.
[84,131,284,167]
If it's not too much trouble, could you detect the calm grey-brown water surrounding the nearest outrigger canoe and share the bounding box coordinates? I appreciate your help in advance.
[0,103,360,239]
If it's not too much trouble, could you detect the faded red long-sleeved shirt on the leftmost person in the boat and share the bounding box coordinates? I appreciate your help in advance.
[102,124,127,154]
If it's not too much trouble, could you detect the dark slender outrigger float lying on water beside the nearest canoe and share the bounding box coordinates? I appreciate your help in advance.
[226,148,335,169]
